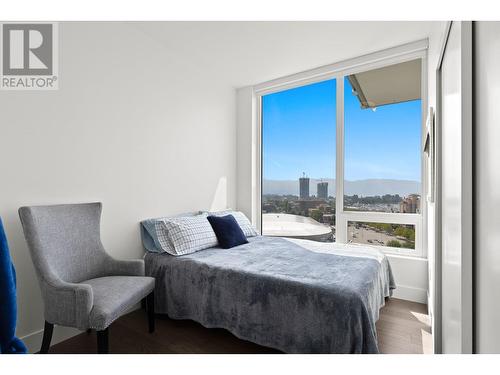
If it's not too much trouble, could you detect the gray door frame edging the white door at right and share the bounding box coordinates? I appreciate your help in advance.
[433,21,474,353]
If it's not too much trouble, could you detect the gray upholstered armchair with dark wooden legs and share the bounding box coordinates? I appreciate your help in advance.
[19,203,155,353]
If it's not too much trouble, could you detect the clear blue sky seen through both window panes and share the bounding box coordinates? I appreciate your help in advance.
[262,79,421,181]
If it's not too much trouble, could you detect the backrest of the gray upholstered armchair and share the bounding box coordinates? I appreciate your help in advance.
[19,203,107,283]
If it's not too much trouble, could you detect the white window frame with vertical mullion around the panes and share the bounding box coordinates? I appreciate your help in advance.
[253,40,428,257]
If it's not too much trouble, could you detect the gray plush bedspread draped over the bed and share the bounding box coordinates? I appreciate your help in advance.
[145,236,395,353]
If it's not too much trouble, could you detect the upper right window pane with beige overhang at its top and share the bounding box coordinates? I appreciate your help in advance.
[344,60,422,213]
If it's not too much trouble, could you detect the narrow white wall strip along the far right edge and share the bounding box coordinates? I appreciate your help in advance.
[473,22,500,353]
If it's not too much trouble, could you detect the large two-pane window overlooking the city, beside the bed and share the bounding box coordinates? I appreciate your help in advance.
[260,58,424,255]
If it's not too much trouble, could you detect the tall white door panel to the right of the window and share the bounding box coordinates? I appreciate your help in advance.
[437,22,472,353]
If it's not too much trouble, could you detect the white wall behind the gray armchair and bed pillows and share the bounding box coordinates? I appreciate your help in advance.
[0,23,236,350]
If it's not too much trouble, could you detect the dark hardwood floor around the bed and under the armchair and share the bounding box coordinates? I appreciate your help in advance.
[50,299,432,354]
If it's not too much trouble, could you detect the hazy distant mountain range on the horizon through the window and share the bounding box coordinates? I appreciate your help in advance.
[263,178,420,197]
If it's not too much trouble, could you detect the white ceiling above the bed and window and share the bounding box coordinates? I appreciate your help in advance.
[134,21,441,87]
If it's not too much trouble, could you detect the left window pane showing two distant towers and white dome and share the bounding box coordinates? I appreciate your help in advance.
[262,79,336,241]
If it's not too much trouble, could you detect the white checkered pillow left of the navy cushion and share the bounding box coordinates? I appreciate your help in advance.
[155,214,217,255]
